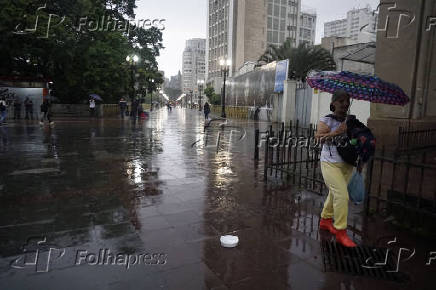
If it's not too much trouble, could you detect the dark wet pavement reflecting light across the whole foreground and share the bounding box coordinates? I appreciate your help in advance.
[0,108,436,290]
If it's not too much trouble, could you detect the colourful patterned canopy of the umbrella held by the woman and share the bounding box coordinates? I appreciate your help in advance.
[307,71,409,106]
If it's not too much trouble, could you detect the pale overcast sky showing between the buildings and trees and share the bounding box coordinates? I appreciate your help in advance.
[136,0,380,77]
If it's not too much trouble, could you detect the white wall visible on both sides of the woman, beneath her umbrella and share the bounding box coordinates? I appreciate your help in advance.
[310,91,370,125]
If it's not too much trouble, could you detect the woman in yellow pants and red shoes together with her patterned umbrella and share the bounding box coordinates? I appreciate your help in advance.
[307,71,410,247]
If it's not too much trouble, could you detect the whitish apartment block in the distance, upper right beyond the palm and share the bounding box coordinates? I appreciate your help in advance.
[324,6,377,43]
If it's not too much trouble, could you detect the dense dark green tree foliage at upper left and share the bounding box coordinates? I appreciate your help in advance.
[0,0,163,103]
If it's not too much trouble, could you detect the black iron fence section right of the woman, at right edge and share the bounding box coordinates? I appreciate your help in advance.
[366,148,436,222]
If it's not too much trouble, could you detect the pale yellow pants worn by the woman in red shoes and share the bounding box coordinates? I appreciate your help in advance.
[321,162,353,230]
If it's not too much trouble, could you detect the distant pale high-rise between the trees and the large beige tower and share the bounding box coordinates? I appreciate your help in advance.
[182,38,206,93]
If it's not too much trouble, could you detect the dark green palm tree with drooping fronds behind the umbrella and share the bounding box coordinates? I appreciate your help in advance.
[259,39,336,82]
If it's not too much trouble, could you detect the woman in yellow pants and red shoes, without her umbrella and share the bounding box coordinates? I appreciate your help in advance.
[315,90,356,247]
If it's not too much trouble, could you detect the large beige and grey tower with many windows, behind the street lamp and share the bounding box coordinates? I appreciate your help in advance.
[206,0,301,90]
